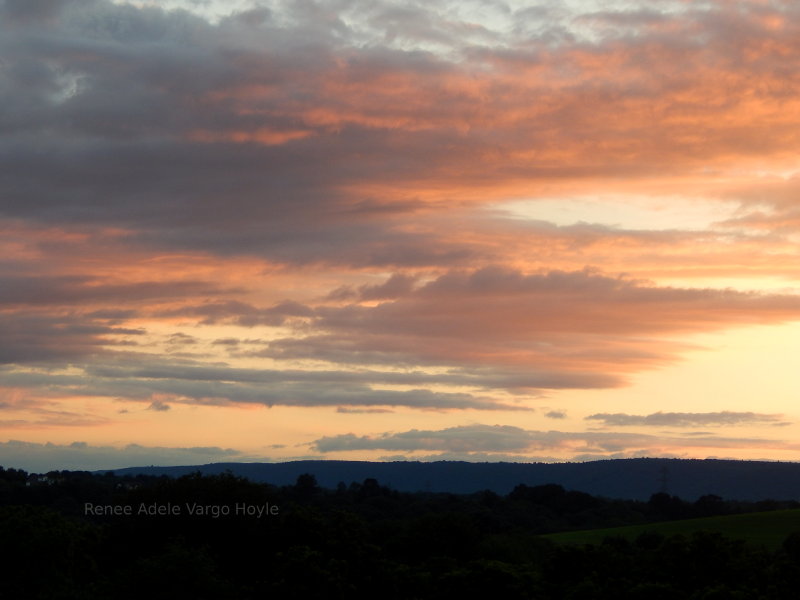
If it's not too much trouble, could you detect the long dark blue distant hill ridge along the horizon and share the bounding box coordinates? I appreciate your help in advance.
[103,458,800,501]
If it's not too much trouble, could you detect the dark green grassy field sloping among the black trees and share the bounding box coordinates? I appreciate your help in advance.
[542,510,800,549]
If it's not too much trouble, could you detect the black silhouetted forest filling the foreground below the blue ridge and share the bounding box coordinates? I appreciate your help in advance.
[0,467,800,600]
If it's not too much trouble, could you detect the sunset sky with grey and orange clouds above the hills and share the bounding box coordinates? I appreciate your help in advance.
[0,0,800,471]
